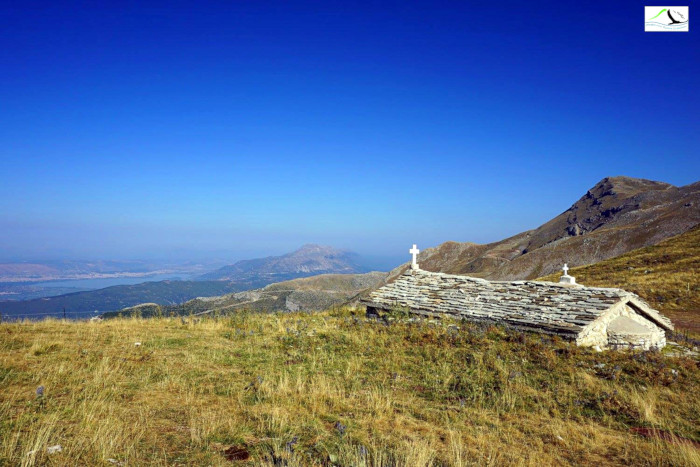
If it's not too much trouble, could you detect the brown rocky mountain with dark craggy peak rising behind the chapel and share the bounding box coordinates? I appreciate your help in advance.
[389,177,700,280]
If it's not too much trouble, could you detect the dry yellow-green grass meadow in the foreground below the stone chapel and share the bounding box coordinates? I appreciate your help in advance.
[0,310,700,466]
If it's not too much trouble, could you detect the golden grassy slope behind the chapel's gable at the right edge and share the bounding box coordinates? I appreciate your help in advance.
[540,225,700,332]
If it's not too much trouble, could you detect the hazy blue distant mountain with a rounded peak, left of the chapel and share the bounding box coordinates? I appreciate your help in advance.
[194,244,366,284]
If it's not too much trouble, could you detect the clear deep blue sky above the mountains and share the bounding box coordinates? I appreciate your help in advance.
[0,1,700,266]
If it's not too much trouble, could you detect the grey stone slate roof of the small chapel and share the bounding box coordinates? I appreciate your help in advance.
[361,270,673,338]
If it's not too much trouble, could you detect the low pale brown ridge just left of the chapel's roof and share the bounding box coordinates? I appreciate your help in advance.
[103,272,387,318]
